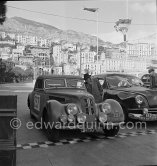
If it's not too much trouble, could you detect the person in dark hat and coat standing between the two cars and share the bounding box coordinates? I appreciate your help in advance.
[84,73,103,103]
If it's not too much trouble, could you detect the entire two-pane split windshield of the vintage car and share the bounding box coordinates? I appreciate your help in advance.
[45,78,85,89]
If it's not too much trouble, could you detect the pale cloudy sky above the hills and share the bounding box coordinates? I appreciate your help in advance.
[7,0,157,43]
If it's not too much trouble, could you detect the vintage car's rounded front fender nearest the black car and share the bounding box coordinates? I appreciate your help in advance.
[104,99,124,123]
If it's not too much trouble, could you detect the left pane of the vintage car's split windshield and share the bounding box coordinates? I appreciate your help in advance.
[45,79,65,88]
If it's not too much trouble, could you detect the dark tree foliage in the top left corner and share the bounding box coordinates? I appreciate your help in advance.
[0,1,7,25]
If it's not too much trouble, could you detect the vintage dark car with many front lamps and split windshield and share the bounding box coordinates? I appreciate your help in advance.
[27,75,124,140]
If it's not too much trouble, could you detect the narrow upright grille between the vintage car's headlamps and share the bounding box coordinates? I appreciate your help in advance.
[81,97,95,115]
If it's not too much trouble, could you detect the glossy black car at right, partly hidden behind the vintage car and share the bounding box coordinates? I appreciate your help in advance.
[94,73,157,121]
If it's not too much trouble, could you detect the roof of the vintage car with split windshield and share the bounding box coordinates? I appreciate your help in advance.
[37,75,83,79]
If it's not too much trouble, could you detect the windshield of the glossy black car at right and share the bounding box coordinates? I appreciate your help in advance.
[107,76,143,88]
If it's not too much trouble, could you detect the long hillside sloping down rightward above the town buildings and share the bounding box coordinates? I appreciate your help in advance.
[0,17,105,45]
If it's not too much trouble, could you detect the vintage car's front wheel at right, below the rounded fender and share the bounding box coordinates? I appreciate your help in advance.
[103,126,119,137]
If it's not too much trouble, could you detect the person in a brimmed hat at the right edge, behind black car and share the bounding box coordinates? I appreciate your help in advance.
[148,68,157,89]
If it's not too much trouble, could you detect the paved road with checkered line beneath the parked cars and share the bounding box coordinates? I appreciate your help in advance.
[0,83,157,166]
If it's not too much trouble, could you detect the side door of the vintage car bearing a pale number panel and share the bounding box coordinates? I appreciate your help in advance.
[32,78,45,118]
